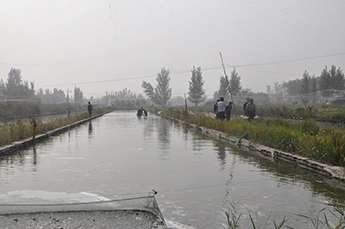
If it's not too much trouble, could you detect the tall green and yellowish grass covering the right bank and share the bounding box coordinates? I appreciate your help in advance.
[153,109,345,166]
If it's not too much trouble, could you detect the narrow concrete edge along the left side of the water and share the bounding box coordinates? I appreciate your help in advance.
[0,112,109,156]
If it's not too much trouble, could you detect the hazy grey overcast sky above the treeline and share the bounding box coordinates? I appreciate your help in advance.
[0,0,345,98]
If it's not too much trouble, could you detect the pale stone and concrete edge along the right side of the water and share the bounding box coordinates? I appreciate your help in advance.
[161,116,345,182]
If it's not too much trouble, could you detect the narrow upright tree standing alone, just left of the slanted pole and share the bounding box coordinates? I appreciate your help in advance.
[188,67,206,106]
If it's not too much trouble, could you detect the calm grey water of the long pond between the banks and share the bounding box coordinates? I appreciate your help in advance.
[0,111,345,228]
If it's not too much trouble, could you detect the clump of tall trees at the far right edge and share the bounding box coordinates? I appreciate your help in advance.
[319,65,344,96]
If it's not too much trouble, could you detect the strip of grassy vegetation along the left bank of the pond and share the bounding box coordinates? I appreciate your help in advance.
[0,109,107,146]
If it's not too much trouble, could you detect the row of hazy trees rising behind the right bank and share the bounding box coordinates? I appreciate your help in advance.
[142,65,345,106]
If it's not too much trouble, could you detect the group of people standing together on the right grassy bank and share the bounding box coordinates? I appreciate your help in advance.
[213,97,256,122]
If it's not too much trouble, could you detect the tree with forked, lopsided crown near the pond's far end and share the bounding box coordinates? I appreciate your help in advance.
[141,67,172,107]
